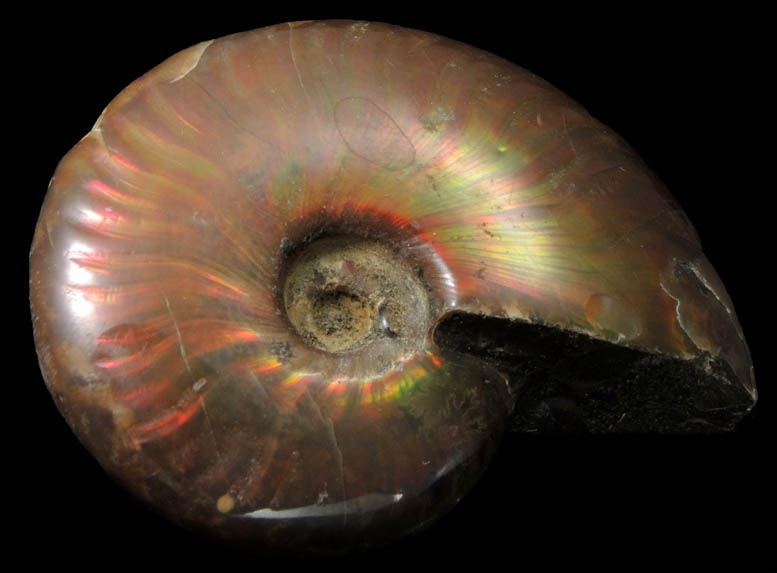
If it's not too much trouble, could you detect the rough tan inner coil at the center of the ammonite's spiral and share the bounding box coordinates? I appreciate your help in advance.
[283,237,430,362]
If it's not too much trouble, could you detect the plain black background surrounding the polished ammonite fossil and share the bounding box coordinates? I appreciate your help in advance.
[16,3,775,569]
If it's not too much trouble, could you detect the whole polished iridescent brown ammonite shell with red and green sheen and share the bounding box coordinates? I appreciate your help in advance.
[30,22,756,551]
